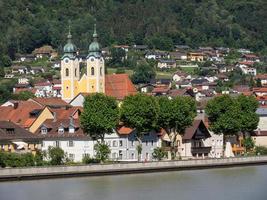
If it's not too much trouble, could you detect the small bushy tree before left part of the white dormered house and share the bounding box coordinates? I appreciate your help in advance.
[48,146,66,165]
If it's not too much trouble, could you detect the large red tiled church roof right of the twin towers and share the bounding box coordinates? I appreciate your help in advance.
[105,74,137,100]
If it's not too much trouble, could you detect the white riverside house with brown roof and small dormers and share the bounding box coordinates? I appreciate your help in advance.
[35,117,96,162]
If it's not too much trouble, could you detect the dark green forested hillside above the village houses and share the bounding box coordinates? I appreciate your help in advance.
[0,0,267,59]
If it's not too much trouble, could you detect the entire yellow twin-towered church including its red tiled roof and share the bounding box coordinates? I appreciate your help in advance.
[61,25,137,102]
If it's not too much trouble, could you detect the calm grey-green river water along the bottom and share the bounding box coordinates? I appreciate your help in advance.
[0,165,267,200]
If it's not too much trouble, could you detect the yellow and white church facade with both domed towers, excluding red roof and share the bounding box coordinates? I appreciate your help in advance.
[61,26,105,102]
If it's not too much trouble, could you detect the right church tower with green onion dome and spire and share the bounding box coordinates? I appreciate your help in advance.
[86,24,105,93]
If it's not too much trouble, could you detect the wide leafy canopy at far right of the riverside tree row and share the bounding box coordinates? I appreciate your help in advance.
[206,95,259,154]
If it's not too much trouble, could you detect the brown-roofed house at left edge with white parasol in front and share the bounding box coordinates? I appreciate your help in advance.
[0,121,41,154]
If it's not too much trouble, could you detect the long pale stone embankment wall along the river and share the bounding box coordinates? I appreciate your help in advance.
[0,156,267,181]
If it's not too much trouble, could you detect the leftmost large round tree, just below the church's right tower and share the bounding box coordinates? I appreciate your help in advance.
[80,93,119,143]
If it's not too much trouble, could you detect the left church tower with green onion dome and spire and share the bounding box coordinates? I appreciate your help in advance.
[61,27,80,102]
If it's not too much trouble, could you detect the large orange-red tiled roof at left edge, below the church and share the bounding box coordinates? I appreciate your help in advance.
[0,101,44,129]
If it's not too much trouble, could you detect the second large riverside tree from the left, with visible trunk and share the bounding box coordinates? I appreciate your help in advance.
[121,94,159,161]
